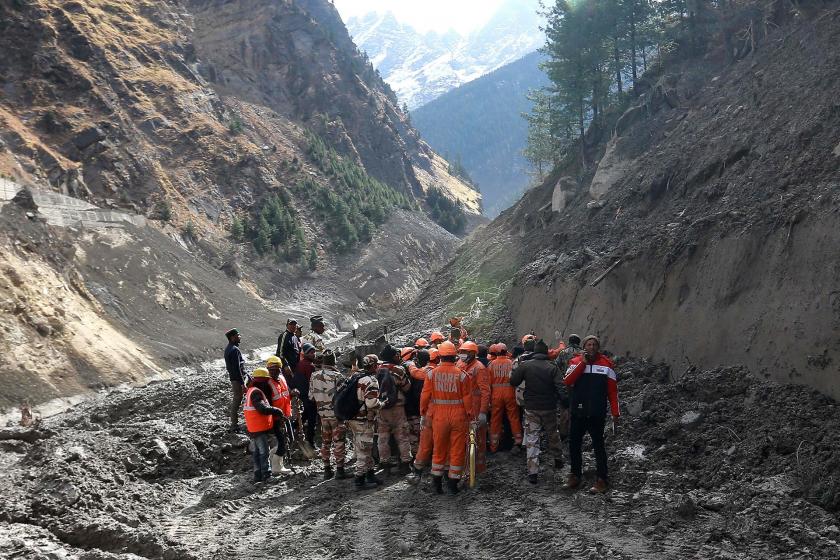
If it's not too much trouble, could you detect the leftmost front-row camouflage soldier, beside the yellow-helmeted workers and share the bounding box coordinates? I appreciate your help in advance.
[309,350,347,480]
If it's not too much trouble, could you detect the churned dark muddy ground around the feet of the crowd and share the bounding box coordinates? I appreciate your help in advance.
[0,361,840,560]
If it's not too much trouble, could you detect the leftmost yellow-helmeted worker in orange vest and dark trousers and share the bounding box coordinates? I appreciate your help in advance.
[244,368,284,483]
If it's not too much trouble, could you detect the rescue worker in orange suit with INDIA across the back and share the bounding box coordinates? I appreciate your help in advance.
[415,342,473,494]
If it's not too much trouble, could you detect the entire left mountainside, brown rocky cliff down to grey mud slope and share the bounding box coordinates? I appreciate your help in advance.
[0,0,472,410]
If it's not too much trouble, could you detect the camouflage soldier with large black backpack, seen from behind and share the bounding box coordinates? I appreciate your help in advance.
[347,354,383,490]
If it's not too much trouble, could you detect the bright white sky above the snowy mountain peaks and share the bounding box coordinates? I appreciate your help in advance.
[335,0,502,34]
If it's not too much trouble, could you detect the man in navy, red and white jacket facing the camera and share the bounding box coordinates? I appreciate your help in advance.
[563,335,619,494]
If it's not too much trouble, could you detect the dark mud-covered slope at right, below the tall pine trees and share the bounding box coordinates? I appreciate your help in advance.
[434,8,840,396]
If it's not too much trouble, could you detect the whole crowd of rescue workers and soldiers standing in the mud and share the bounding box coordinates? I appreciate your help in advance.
[225,316,619,494]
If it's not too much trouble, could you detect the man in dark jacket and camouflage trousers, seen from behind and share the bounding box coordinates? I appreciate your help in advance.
[510,340,565,484]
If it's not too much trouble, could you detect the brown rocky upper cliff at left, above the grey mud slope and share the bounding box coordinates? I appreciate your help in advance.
[0,0,480,240]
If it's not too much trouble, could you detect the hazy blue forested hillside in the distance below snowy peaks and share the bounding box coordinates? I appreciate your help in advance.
[411,52,548,217]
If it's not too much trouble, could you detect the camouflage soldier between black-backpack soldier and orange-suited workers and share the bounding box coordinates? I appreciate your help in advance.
[376,345,411,474]
